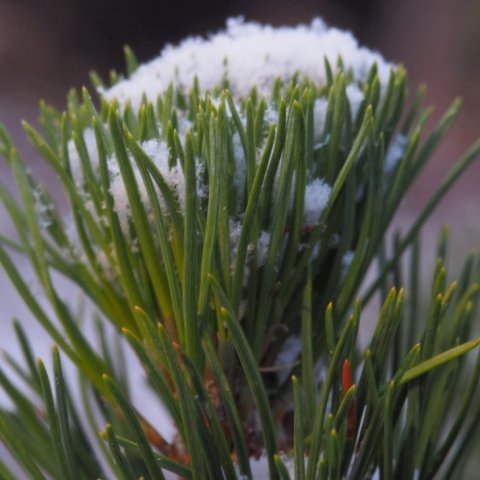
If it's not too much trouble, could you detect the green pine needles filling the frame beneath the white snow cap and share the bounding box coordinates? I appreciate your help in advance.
[0,28,480,480]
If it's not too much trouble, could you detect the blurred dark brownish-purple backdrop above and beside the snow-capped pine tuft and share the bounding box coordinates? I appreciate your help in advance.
[0,0,480,251]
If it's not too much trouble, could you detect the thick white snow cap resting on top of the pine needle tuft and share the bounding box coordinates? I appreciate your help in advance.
[101,18,392,108]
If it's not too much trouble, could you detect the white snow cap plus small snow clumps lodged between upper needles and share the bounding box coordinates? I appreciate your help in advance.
[68,18,398,265]
